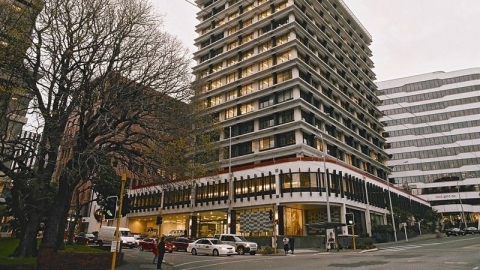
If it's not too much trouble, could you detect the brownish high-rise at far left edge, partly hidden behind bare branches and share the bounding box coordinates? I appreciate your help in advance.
[0,0,42,193]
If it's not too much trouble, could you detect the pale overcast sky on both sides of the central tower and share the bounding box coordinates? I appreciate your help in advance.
[150,0,480,81]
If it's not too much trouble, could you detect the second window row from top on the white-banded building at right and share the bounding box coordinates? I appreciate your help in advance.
[382,85,480,106]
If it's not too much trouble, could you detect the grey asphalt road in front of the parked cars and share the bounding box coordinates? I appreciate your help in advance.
[116,235,480,270]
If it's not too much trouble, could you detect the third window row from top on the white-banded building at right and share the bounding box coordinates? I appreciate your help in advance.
[383,95,480,115]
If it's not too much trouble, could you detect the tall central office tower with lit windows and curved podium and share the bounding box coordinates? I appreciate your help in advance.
[108,0,429,240]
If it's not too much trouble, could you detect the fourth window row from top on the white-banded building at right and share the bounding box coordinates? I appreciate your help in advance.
[384,108,480,126]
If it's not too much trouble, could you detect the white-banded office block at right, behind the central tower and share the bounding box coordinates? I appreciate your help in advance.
[377,68,480,228]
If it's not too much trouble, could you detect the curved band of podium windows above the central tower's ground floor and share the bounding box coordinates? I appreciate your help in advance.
[125,171,429,217]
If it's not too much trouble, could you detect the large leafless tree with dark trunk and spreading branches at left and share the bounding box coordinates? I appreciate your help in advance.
[0,0,197,257]
